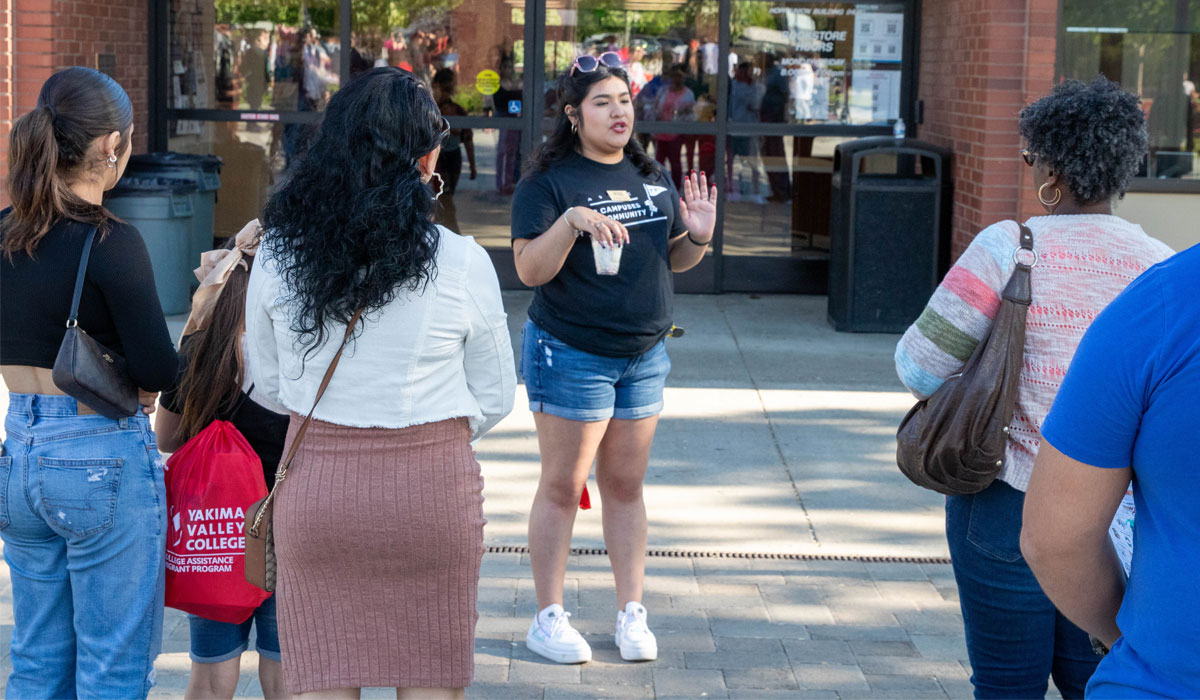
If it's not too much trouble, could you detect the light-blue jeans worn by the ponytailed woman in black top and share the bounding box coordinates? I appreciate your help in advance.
[0,394,167,698]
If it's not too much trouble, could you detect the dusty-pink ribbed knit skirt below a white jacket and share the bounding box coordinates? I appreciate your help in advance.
[274,414,484,693]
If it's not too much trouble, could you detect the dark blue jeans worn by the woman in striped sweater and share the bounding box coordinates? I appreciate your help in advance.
[946,480,1100,700]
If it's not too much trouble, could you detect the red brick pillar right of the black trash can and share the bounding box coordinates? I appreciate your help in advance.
[919,0,1058,257]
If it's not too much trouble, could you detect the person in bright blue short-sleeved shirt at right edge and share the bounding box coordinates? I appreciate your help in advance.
[1021,246,1200,698]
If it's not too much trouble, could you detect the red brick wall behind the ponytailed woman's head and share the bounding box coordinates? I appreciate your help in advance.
[0,0,150,207]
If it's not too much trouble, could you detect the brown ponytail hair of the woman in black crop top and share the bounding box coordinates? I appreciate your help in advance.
[0,66,133,259]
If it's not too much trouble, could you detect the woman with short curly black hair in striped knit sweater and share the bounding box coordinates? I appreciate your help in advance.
[895,73,1171,699]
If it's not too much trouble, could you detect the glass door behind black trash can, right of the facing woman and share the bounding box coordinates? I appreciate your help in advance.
[721,0,912,293]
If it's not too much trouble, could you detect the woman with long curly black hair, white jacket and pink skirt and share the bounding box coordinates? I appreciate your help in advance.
[246,67,516,698]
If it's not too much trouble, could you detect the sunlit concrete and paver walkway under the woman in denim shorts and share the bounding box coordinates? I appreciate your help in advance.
[0,293,1008,698]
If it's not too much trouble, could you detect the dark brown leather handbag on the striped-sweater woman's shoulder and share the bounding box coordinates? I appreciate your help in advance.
[896,223,1038,496]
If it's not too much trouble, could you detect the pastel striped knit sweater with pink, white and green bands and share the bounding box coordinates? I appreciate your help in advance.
[895,215,1172,491]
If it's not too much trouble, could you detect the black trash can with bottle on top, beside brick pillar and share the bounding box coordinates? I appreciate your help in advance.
[828,137,952,333]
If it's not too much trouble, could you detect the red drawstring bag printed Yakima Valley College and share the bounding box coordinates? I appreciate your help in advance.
[167,420,271,623]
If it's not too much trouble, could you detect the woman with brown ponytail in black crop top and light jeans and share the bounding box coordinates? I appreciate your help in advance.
[0,67,179,698]
